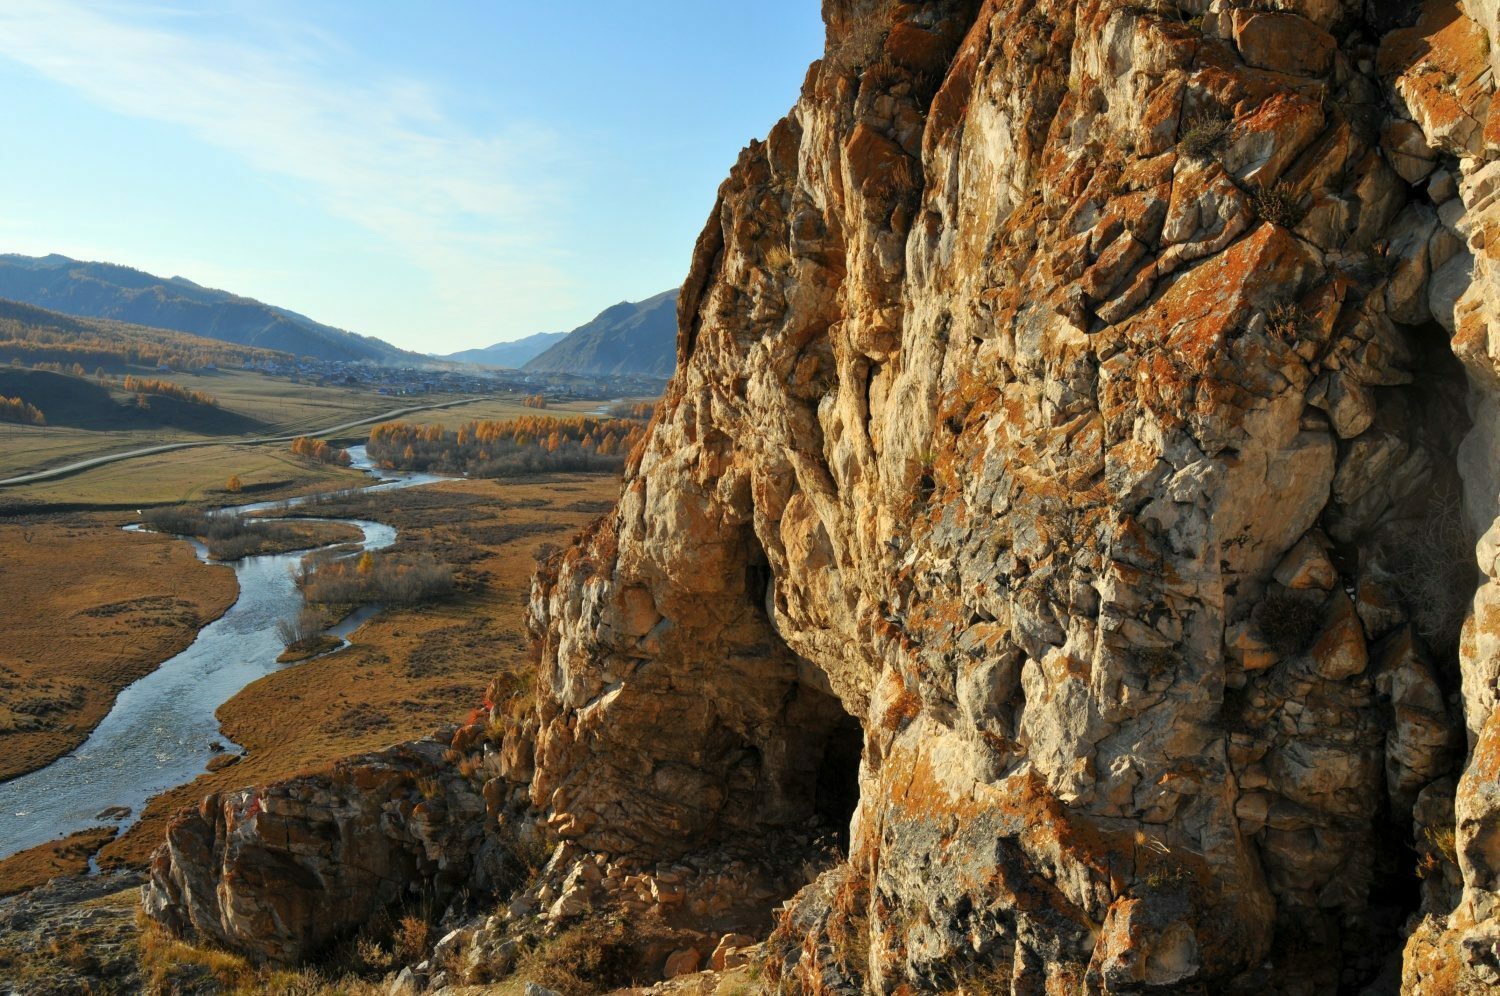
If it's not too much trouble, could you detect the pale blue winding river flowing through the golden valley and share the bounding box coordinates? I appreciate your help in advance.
[0,447,443,858]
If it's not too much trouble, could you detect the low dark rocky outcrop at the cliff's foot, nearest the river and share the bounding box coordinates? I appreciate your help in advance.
[143,740,515,962]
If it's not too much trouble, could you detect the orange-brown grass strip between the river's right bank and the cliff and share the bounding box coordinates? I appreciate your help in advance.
[98,474,620,867]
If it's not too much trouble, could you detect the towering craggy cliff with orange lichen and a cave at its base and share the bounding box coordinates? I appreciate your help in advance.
[147,0,1500,993]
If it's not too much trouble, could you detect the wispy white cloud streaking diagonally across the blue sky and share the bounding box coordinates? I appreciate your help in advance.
[0,0,567,342]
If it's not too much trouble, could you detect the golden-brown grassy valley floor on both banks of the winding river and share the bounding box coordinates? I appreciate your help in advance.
[0,426,620,992]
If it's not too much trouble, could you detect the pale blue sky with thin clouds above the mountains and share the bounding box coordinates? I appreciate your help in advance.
[0,0,822,353]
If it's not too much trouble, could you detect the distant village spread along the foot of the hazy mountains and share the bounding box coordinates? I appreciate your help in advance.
[245,357,666,402]
